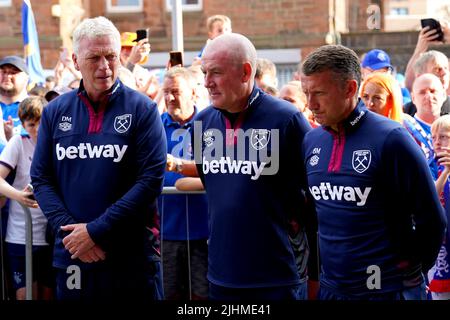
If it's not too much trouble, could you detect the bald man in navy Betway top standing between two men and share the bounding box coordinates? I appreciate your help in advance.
[193,33,317,300]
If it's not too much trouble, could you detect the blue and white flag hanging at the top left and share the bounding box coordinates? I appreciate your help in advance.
[22,0,45,84]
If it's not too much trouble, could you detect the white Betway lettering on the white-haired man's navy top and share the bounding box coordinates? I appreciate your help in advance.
[56,142,128,162]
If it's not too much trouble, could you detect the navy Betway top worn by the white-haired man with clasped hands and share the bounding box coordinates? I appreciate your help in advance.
[31,80,166,268]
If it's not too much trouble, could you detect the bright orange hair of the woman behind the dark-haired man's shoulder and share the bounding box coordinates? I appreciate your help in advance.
[360,72,403,123]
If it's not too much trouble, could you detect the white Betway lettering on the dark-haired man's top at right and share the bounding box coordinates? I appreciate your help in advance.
[309,182,372,207]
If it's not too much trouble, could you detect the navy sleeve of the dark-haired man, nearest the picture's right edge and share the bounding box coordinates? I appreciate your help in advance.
[381,128,447,272]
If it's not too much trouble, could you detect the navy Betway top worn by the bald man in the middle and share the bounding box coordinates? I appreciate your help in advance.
[193,87,314,288]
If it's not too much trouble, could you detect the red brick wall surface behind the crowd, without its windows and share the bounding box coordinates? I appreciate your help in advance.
[0,0,394,68]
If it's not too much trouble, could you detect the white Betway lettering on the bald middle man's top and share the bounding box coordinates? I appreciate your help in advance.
[202,157,266,180]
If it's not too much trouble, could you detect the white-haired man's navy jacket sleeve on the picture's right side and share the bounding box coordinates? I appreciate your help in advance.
[87,102,167,245]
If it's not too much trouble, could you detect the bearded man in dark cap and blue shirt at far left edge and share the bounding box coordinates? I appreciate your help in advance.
[0,56,29,141]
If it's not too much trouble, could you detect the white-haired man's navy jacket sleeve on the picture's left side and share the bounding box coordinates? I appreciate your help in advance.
[30,106,77,234]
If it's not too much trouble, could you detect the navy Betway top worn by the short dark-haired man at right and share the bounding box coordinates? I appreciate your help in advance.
[303,103,446,297]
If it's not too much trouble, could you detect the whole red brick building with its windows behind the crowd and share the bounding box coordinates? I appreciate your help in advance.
[0,0,417,82]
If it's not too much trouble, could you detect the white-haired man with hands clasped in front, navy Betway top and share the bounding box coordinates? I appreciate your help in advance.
[31,17,166,300]
